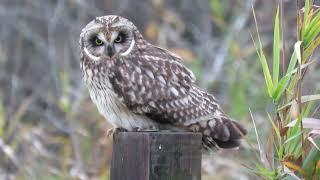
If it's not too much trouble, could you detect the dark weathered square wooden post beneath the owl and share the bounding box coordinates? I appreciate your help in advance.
[110,132,201,180]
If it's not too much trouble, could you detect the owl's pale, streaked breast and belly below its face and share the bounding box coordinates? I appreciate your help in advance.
[83,66,158,131]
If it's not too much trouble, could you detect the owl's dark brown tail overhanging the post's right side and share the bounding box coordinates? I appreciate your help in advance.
[188,117,247,150]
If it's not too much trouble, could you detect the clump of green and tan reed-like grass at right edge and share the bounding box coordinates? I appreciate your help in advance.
[253,0,320,179]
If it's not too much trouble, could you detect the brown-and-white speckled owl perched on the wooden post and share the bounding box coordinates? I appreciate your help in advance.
[80,15,246,148]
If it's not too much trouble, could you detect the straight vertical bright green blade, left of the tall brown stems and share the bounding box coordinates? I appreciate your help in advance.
[273,6,280,86]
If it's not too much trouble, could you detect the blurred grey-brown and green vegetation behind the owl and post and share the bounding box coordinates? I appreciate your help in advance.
[0,0,320,180]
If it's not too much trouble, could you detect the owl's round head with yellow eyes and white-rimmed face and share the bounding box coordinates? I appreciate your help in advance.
[80,15,141,61]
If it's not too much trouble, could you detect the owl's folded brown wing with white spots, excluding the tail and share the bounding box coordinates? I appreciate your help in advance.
[110,46,218,124]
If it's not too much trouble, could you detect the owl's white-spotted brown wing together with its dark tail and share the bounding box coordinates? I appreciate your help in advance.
[110,46,246,148]
